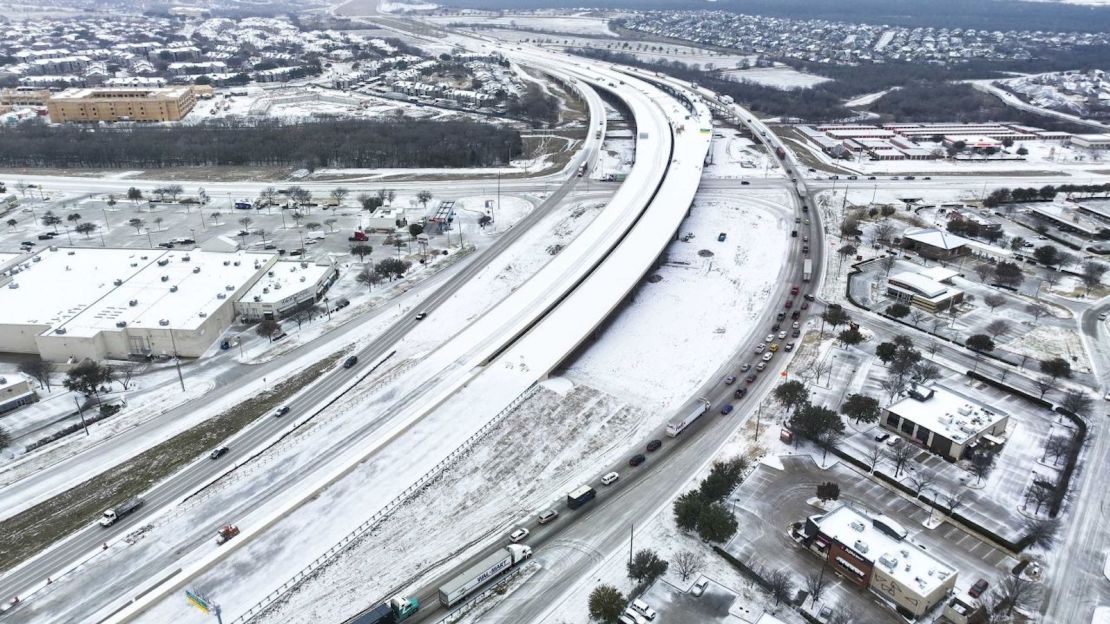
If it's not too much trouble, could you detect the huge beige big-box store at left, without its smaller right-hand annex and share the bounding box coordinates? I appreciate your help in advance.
[0,248,278,362]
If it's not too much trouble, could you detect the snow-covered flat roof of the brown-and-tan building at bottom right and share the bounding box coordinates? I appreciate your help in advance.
[813,505,956,596]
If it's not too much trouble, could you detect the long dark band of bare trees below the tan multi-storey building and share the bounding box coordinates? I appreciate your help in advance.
[0,120,523,170]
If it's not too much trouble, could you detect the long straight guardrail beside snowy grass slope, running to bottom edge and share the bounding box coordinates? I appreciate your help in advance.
[232,383,539,624]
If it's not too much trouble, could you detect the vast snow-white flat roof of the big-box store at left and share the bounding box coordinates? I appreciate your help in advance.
[0,248,276,336]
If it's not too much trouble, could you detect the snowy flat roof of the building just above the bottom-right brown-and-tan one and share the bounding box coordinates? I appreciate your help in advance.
[887,385,1009,444]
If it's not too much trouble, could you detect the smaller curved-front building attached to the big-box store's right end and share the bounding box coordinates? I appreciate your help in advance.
[235,261,339,321]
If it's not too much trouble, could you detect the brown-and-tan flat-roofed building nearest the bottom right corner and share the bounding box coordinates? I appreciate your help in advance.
[796,505,957,618]
